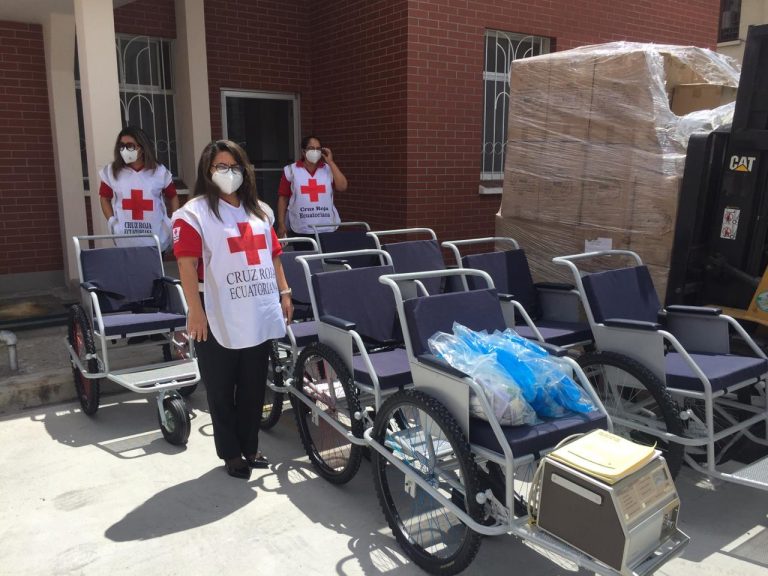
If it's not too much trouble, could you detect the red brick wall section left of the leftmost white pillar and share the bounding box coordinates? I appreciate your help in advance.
[0,22,63,275]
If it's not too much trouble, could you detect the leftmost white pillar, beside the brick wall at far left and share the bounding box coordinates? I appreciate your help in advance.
[43,14,88,284]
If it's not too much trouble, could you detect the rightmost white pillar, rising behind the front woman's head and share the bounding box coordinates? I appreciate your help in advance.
[174,0,211,190]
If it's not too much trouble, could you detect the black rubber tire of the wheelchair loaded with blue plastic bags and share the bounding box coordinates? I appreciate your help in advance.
[371,390,482,576]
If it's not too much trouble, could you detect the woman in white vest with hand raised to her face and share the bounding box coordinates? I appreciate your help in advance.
[277,136,347,243]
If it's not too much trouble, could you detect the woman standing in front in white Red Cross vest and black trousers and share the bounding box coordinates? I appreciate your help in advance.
[173,140,293,479]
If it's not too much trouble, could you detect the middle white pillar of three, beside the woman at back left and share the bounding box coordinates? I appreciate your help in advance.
[74,0,122,234]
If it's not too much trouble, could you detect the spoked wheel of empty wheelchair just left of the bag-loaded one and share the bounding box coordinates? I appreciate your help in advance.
[292,343,363,484]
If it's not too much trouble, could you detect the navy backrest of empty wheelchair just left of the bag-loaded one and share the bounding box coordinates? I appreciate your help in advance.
[312,265,403,343]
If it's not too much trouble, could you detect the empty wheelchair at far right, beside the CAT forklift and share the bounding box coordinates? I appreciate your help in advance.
[553,250,768,490]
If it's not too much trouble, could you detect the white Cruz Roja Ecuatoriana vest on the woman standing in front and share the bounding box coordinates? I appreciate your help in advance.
[173,196,285,349]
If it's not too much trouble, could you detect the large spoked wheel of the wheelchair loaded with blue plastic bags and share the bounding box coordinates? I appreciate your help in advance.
[373,390,482,575]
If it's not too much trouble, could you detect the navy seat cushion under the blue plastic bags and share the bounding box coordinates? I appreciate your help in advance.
[469,411,608,457]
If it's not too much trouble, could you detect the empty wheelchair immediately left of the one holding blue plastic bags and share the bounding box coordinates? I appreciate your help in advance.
[289,250,411,484]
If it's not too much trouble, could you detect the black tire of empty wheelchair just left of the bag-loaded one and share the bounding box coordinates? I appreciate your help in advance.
[291,342,363,484]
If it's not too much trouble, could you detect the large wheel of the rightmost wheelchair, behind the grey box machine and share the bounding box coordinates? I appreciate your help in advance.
[578,352,685,478]
